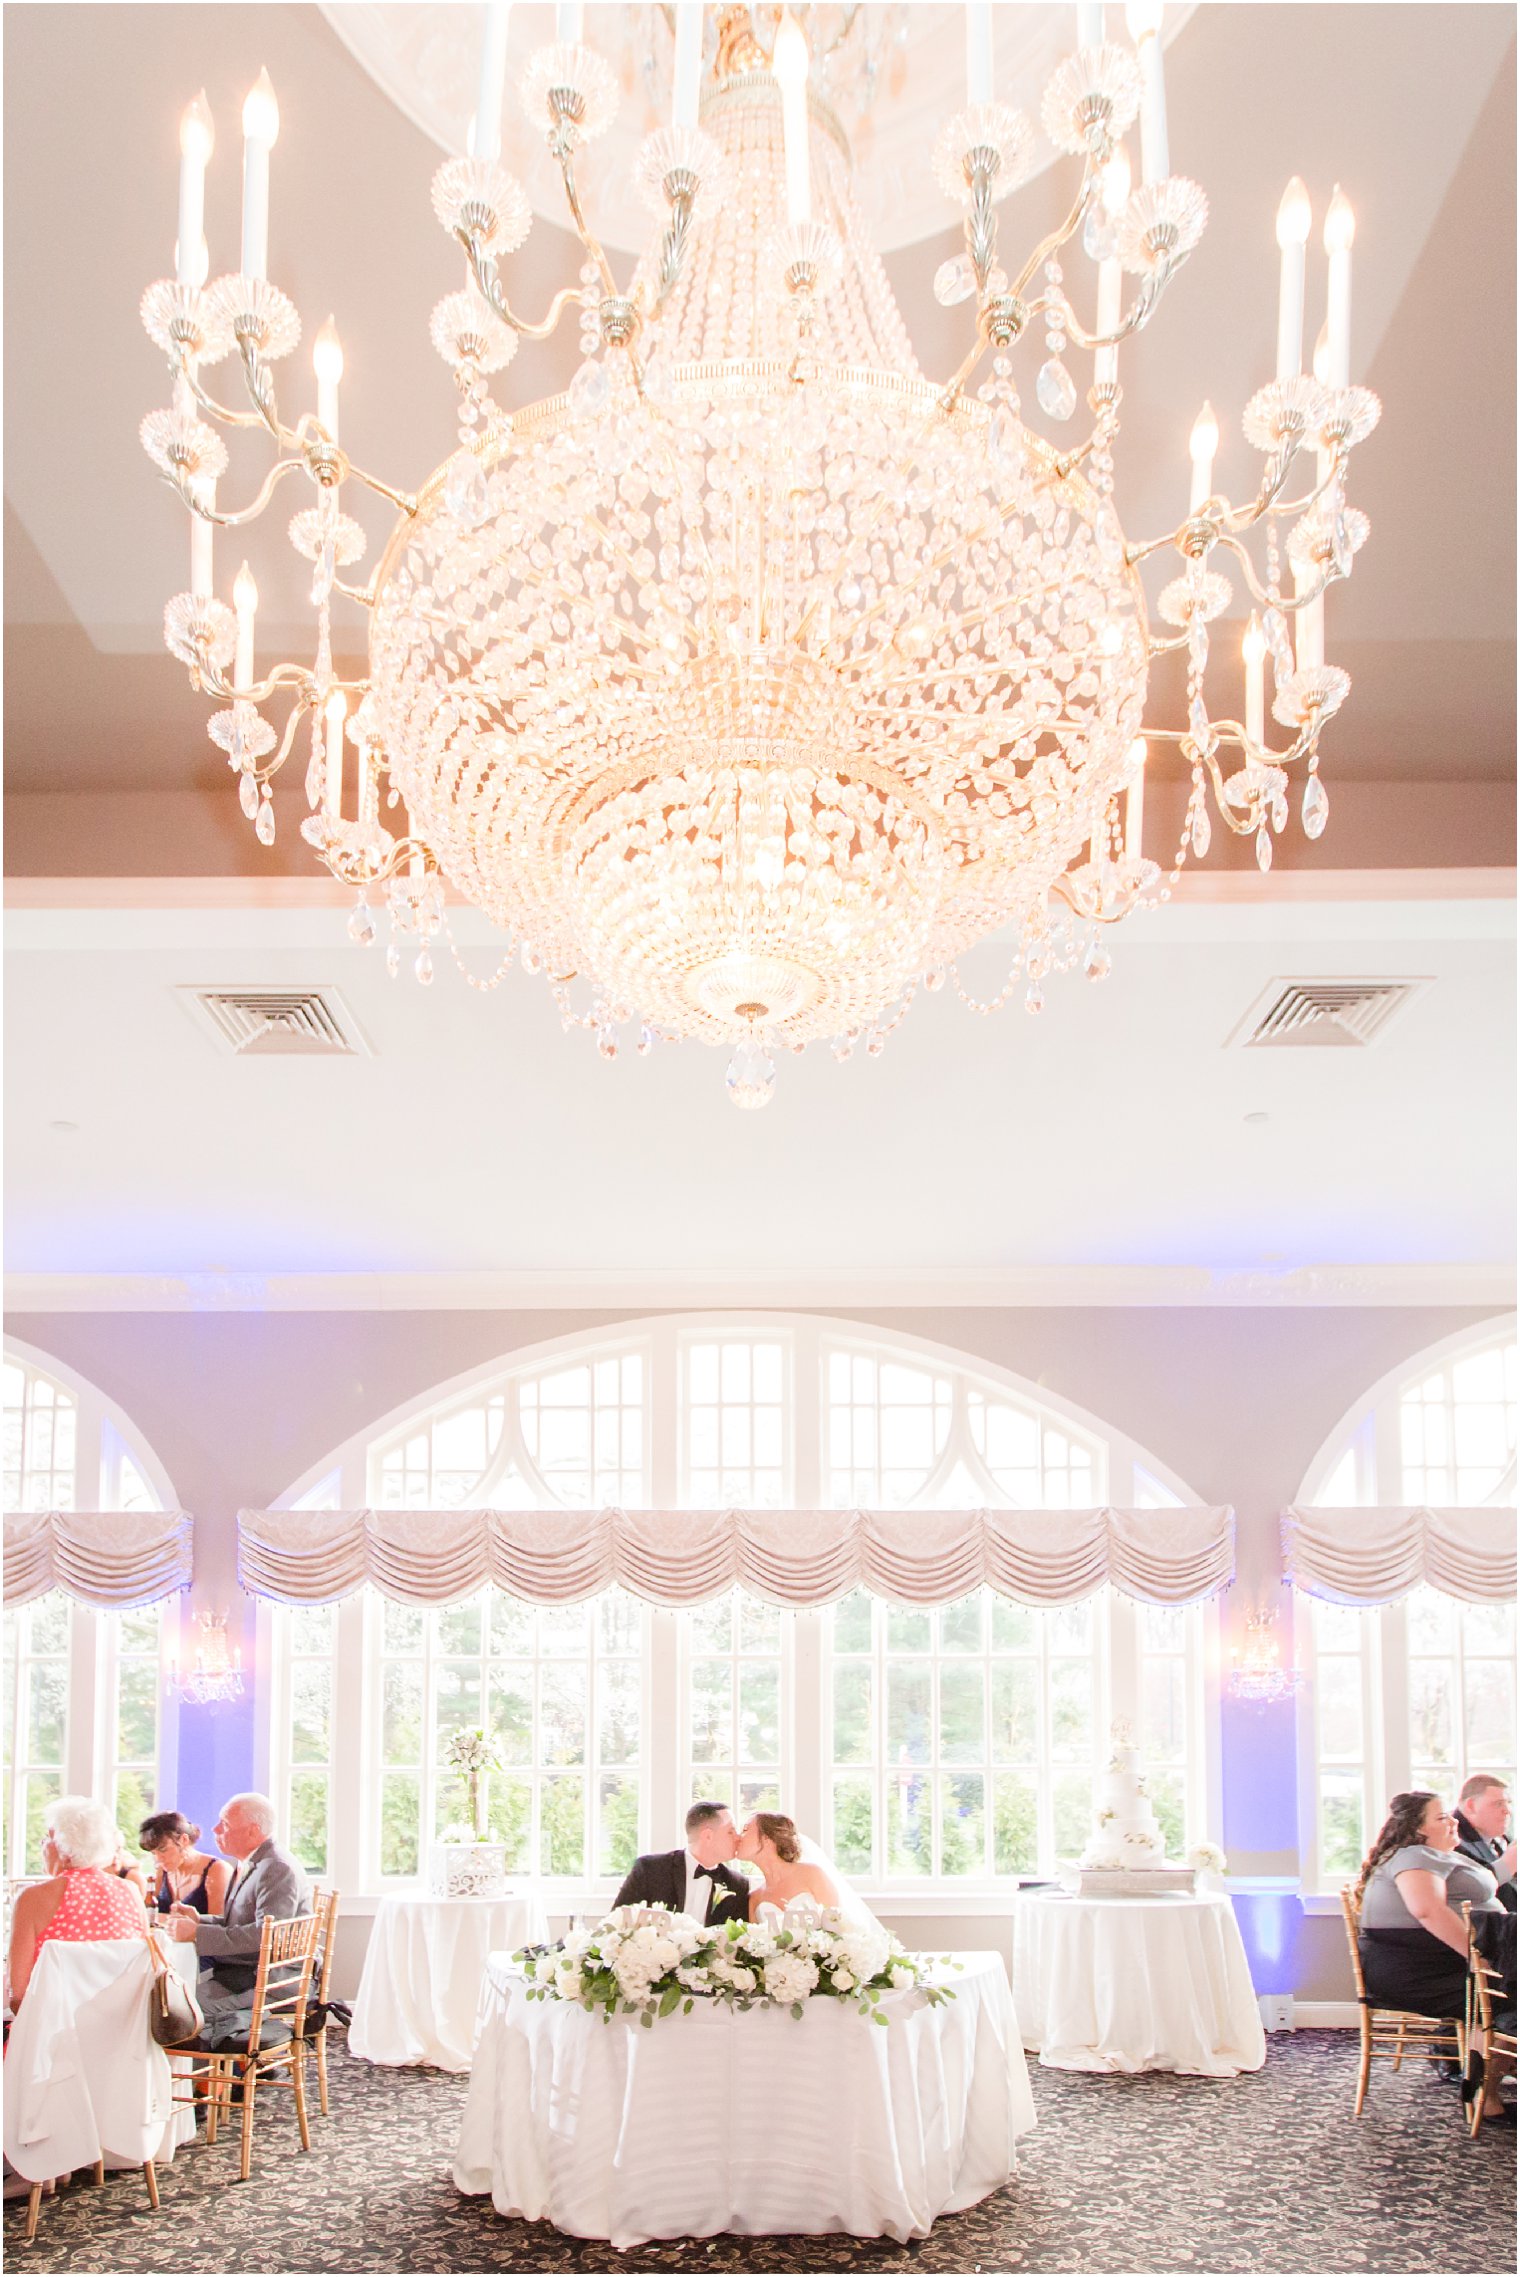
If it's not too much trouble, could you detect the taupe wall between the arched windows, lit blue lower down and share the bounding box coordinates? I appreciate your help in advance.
[7,1307,1497,1999]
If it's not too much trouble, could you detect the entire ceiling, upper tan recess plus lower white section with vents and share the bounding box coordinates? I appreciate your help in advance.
[5,0,1515,1277]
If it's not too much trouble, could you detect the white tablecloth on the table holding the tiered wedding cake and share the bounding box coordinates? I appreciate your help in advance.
[1013,1892,1267,2079]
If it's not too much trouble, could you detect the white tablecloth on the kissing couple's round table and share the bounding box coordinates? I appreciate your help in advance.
[453,1954,1035,2250]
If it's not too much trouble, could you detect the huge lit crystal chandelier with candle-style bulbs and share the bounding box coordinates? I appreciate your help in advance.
[141,0,1379,1107]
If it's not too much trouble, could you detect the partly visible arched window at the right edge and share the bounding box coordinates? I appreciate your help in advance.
[1297,1318,1515,1890]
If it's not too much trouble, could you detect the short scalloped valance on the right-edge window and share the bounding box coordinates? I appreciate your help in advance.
[1283,1505,1515,1605]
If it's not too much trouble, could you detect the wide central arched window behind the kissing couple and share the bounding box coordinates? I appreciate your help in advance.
[266,1314,1208,1904]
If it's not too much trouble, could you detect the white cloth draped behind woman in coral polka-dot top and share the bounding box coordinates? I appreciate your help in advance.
[5,1938,196,2181]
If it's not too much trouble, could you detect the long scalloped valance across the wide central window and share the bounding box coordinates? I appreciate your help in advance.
[237,1507,1236,1605]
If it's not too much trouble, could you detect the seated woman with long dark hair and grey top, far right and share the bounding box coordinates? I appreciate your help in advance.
[1356,1787,1515,2115]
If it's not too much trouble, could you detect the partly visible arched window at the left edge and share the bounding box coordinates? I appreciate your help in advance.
[2,1341,175,1876]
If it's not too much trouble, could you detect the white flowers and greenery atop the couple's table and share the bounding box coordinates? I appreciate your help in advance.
[517,1906,953,2024]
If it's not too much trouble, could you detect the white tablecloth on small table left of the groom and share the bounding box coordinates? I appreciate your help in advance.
[348,1892,548,2072]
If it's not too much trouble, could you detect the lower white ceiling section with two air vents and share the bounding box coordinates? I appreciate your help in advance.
[7,899,1515,1277]
